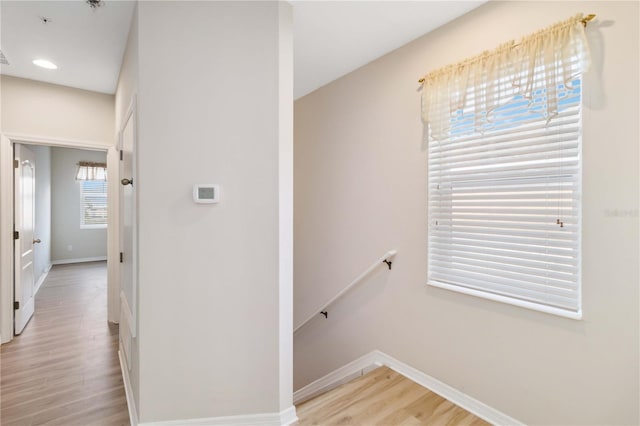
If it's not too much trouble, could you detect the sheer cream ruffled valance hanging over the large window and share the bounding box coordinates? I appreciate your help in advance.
[422,14,590,143]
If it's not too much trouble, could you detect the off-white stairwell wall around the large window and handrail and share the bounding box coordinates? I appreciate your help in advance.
[294,1,640,424]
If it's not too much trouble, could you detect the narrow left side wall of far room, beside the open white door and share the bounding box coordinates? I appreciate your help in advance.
[29,146,51,284]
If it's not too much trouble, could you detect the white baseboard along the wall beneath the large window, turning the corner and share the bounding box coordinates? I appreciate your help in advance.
[293,351,524,426]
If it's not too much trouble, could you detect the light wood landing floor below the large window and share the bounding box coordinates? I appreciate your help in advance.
[296,367,488,426]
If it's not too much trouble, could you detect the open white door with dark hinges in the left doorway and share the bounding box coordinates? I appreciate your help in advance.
[13,144,36,335]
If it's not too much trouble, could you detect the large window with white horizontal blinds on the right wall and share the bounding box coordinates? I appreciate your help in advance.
[423,15,584,319]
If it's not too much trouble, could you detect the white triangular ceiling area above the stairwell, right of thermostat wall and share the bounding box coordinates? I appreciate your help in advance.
[290,0,486,99]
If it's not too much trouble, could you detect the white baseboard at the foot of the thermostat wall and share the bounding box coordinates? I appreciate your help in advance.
[139,406,298,426]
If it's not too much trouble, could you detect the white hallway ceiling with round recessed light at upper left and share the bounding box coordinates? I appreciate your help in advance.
[0,0,134,93]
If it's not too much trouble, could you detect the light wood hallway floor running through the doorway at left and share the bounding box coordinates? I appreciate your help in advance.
[0,262,129,426]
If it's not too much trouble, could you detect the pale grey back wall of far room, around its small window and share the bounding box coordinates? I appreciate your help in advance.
[51,147,107,263]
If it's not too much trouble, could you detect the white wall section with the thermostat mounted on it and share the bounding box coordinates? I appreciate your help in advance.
[127,2,292,422]
